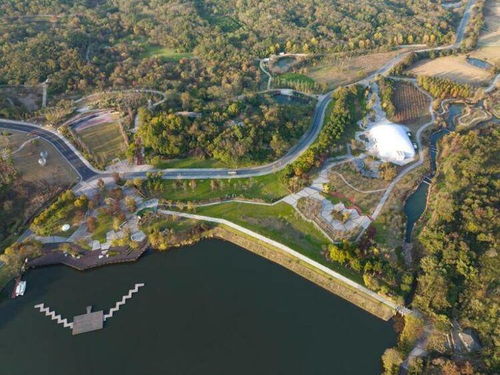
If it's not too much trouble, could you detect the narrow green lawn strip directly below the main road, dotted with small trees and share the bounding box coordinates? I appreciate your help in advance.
[142,171,288,202]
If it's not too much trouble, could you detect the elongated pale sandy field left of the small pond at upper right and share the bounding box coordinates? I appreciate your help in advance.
[408,55,493,86]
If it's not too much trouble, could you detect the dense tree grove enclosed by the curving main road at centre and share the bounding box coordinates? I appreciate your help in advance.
[136,95,313,166]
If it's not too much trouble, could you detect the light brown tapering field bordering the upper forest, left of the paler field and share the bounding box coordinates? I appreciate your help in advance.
[305,50,403,87]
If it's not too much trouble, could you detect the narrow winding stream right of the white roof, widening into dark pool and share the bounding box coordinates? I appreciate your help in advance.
[404,104,463,242]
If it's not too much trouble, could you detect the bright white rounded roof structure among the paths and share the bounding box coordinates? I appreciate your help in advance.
[366,119,415,165]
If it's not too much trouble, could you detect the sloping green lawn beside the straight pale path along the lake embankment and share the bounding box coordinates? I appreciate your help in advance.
[196,203,362,283]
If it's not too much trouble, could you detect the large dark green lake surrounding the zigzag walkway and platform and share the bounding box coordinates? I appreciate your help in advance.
[0,240,396,375]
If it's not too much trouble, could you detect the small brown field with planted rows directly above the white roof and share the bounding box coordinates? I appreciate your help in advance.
[390,82,431,130]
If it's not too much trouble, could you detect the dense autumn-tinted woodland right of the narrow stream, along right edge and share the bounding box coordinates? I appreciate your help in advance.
[414,124,500,373]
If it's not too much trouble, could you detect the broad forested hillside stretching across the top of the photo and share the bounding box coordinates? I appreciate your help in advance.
[0,0,456,96]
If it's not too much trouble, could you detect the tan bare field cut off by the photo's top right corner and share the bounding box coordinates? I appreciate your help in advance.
[471,0,500,67]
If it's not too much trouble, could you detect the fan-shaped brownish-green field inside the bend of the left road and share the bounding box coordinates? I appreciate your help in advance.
[78,122,126,164]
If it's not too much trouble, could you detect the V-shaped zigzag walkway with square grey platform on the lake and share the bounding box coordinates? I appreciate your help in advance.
[34,283,145,335]
